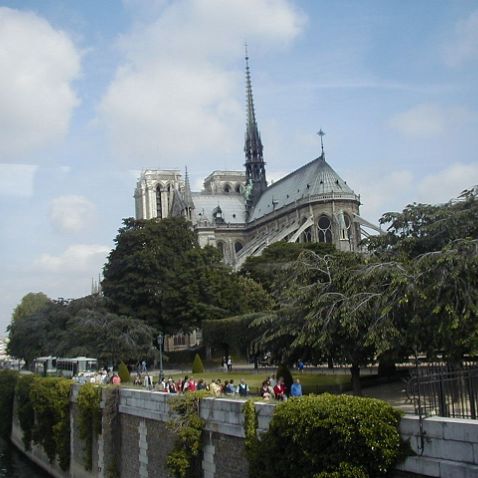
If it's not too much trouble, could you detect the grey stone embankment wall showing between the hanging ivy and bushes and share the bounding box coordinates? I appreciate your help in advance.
[12,387,478,478]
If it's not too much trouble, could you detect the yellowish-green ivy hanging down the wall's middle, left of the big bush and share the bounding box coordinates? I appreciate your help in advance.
[166,392,207,478]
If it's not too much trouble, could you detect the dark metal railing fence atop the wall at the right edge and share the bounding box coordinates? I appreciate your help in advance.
[406,364,478,420]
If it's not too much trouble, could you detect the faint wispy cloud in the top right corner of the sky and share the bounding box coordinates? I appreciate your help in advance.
[445,10,478,67]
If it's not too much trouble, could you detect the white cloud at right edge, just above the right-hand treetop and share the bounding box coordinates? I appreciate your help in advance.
[417,163,478,204]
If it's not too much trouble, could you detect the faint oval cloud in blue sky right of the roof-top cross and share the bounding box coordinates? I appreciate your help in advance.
[388,103,472,138]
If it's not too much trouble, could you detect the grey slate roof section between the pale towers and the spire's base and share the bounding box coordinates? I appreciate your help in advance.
[192,192,246,225]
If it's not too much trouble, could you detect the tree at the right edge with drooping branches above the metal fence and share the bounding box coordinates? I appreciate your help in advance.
[367,187,478,362]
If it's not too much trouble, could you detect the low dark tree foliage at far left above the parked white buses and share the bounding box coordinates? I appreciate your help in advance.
[9,296,154,364]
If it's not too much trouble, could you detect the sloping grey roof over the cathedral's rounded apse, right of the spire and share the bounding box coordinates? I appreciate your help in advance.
[249,155,358,222]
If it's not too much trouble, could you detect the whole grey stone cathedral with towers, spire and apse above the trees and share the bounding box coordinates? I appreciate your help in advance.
[134,55,381,269]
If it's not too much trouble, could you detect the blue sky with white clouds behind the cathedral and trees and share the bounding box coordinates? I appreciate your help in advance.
[0,0,478,335]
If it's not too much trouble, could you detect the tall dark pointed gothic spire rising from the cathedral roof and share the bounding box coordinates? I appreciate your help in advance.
[244,44,267,209]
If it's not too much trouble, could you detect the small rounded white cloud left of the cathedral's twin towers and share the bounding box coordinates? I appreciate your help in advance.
[50,195,96,232]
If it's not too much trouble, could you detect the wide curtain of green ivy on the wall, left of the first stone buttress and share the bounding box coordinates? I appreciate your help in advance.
[30,377,71,470]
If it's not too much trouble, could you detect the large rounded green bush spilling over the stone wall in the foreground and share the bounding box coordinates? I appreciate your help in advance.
[251,394,404,478]
